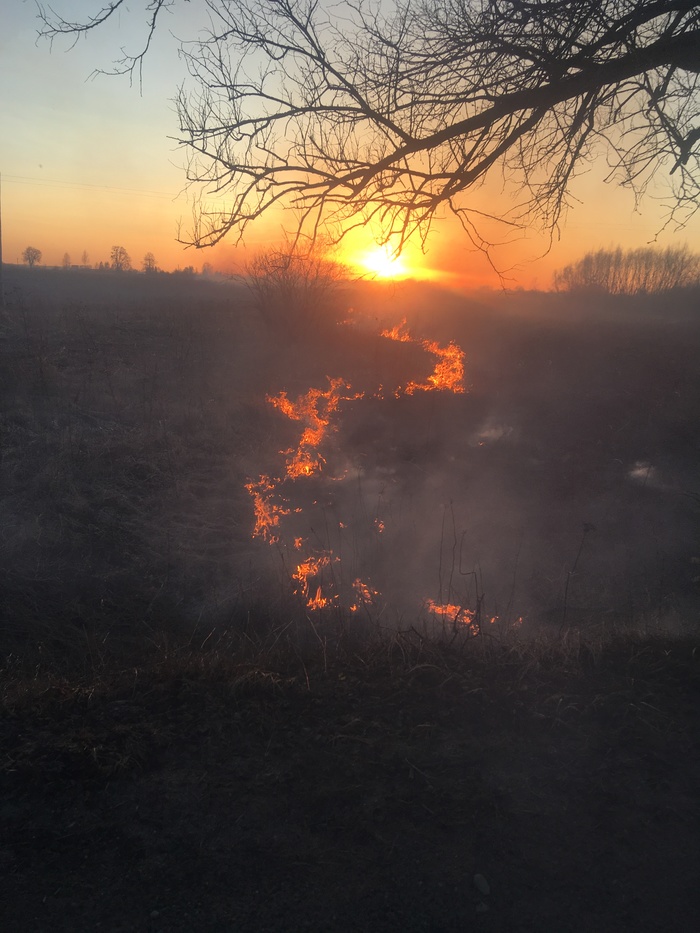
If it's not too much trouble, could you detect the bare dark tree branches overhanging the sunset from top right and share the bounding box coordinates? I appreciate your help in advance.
[42,0,700,260]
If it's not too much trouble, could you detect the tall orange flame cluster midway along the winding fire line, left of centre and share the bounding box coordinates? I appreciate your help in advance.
[267,377,362,479]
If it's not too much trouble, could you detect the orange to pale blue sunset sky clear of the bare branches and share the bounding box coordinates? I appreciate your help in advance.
[0,0,700,288]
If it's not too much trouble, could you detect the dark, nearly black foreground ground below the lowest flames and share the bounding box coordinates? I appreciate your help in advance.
[0,635,700,933]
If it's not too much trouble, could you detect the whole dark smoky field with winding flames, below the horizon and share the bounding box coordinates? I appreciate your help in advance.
[0,268,700,933]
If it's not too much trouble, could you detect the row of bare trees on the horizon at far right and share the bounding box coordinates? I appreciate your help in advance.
[554,246,700,295]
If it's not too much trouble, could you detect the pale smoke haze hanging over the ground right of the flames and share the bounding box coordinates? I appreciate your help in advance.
[234,288,690,630]
